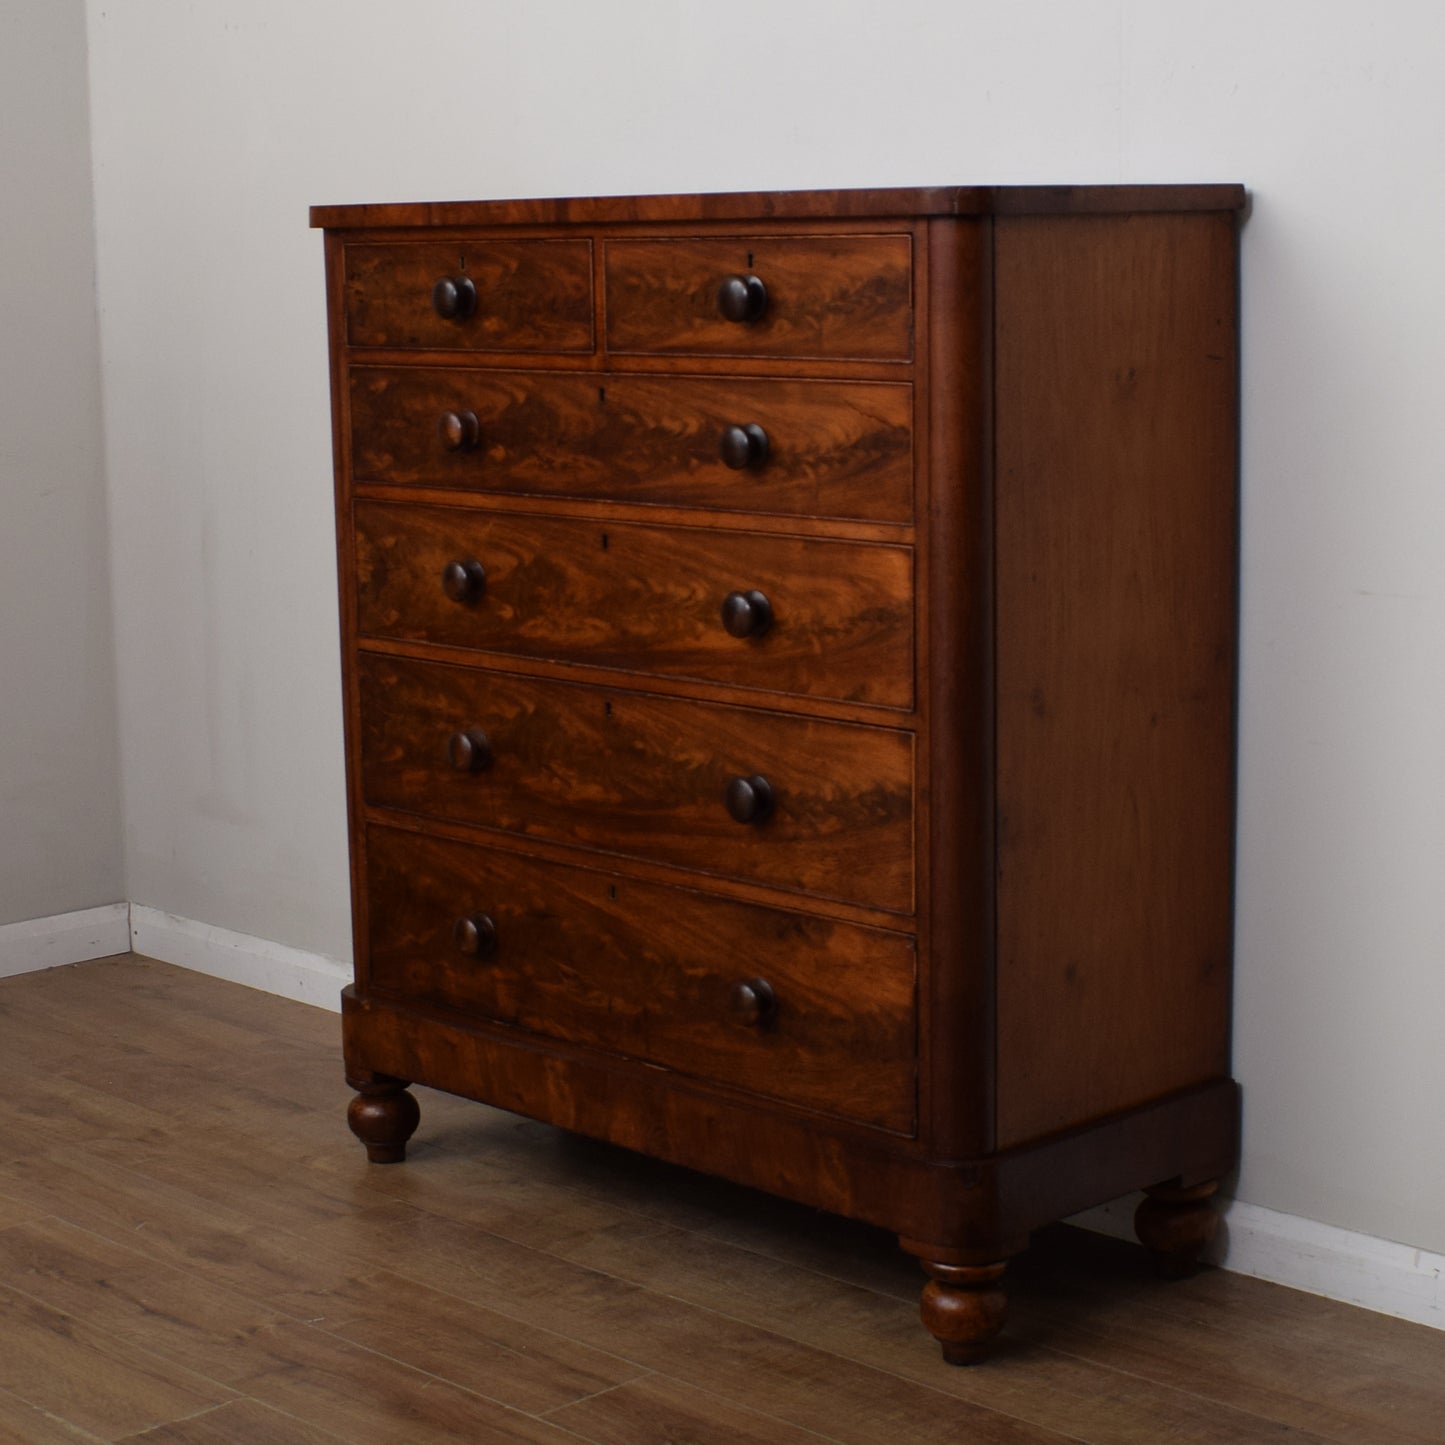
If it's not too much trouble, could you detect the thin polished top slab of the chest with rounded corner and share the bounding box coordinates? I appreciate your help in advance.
[311,185,1247,231]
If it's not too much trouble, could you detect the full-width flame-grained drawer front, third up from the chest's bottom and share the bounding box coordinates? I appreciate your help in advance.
[354,501,913,708]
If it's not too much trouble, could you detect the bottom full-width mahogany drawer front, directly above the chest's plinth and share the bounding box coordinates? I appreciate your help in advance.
[367,827,916,1131]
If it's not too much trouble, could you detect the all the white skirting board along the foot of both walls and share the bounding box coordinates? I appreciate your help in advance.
[8,903,1445,1329]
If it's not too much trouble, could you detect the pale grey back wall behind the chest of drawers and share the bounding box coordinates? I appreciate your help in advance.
[76,0,1445,1251]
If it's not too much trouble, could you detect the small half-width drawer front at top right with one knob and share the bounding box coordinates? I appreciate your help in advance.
[605,234,913,361]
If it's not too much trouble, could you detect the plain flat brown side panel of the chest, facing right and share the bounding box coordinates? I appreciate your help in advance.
[994,215,1237,1144]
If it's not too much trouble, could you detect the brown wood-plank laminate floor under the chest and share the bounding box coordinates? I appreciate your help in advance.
[0,957,1445,1445]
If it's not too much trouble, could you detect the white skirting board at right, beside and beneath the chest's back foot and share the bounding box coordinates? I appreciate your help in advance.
[1069,1195,1445,1329]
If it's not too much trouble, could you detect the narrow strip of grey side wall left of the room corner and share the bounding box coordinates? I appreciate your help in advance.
[0,0,126,923]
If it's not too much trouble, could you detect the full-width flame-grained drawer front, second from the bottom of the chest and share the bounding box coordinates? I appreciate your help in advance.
[358,655,913,913]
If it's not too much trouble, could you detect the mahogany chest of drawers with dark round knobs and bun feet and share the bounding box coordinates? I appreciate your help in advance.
[312,186,1244,1363]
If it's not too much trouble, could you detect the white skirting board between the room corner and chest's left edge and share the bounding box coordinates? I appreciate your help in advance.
[127,903,351,1013]
